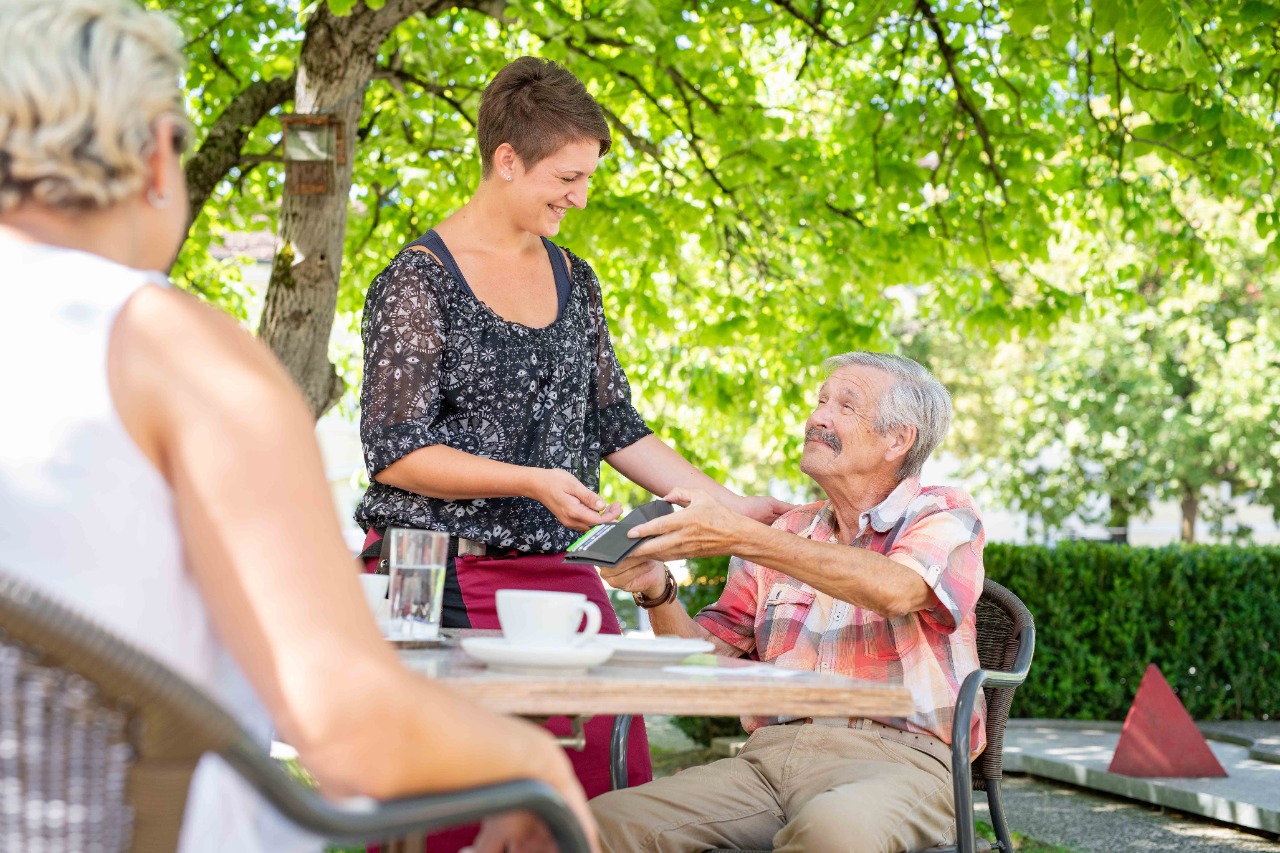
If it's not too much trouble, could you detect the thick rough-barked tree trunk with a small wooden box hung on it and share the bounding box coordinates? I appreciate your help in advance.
[259,0,455,418]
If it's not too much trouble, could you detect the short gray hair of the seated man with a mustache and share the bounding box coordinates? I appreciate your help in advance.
[822,352,951,480]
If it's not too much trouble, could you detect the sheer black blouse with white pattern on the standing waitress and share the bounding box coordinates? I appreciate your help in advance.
[356,233,652,553]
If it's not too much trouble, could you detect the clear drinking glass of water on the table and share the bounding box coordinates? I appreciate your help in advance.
[387,528,449,639]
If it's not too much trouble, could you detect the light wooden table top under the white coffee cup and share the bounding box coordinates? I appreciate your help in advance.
[401,631,913,717]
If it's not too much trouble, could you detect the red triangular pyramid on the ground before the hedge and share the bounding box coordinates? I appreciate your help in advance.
[1107,663,1226,779]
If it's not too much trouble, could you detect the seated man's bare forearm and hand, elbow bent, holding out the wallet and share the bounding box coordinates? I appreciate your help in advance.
[630,491,937,619]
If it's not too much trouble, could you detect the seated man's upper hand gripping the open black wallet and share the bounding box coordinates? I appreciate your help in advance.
[627,489,756,560]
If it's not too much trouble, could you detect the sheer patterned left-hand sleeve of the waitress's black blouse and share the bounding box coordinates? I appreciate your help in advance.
[360,251,445,476]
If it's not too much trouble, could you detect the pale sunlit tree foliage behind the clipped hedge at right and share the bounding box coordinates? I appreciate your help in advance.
[909,188,1280,542]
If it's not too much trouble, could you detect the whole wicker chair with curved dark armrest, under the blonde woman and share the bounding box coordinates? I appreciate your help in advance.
[0,563,589,853]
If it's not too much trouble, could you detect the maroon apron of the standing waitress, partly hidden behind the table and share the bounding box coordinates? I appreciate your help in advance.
[365,529,653,853]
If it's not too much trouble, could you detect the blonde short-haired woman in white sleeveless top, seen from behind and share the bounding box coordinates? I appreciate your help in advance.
[0,0,594,852]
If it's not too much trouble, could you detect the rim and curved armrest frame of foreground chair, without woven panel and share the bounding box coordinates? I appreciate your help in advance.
[0,563,589,853]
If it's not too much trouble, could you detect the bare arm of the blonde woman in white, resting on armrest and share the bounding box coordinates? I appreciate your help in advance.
[109,288,593,845]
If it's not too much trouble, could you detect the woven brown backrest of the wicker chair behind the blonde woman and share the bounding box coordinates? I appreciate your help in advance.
[0,571,287,853]
